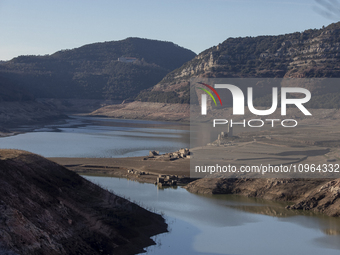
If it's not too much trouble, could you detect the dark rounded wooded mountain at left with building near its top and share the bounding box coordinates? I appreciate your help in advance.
[0,38,196,99]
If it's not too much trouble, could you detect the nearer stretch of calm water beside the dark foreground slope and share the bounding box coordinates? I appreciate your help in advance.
[86,176,340,255]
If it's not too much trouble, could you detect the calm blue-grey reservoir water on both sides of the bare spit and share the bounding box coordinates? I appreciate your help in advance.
[0,117,340,255]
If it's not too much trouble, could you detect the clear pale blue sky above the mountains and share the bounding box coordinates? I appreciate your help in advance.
[0,0,337,60]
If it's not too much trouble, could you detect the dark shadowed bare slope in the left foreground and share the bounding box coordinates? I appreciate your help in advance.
[0,150,167,255]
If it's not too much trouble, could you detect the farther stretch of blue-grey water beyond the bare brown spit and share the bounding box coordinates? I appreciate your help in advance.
[0,117,189,158]
